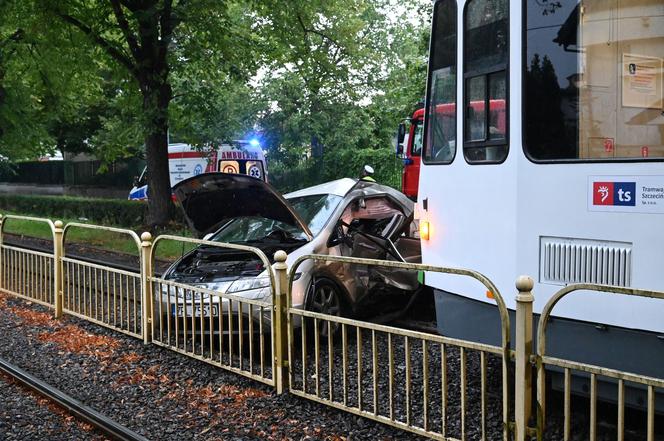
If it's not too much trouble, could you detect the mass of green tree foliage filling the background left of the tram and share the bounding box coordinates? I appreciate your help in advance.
[0,0,432,203]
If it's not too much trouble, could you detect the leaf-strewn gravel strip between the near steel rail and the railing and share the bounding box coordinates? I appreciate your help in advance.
[0,294,430,440]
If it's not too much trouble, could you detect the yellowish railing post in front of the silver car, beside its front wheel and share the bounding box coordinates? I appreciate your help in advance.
[272,250,289,394]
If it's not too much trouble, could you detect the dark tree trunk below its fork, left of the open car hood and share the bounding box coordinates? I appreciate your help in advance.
[143,81,172,226]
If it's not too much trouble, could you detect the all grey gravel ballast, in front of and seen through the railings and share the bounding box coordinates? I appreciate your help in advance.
[0,293,662,441]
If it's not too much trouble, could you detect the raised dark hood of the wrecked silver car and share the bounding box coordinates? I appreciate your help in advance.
[173,173,312,240]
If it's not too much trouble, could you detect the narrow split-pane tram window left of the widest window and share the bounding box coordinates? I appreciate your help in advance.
[464,0,509,163]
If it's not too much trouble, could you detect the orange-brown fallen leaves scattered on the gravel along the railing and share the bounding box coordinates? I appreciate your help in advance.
[0,293,346,441]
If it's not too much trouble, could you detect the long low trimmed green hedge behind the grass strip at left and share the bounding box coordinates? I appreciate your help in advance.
[0,194,147,228]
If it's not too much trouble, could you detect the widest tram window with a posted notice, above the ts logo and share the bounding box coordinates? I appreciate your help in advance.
[523,0,664,161]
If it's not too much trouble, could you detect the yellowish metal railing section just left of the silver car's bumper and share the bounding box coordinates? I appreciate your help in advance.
[61,222,143,338]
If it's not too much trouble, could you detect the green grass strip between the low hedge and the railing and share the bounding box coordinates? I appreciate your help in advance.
[2,212,193,260]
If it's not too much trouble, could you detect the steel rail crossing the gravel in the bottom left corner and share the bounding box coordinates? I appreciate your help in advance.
[0,358,148,441]
